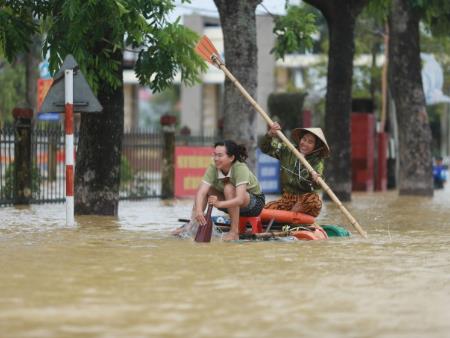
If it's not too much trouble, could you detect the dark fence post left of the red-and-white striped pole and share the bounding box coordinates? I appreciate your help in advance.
[12,108,33,204]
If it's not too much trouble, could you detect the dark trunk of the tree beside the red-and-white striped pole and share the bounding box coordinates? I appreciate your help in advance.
[75,51,124,216]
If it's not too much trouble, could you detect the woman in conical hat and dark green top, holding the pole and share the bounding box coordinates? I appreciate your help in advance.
[259,122,330,217]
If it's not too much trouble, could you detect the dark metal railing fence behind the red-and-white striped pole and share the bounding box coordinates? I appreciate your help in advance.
[0,123,217,205]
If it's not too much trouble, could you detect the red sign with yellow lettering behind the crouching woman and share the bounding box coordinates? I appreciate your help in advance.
[175,147,214,197]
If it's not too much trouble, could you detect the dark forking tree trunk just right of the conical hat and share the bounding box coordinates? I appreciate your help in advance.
[305,0,367,201]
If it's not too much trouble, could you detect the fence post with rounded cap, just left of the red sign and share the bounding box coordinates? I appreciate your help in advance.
[160,114,177,198]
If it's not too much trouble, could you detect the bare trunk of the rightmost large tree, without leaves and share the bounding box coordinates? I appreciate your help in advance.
[389,0,433,196]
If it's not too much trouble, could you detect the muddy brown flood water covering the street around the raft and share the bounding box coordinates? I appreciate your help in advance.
[0,186,450,338]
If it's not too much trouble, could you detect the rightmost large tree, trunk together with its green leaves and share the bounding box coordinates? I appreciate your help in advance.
[358,0,450,196]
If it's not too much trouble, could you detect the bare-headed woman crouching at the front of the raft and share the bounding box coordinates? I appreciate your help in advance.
[173,140,265,240]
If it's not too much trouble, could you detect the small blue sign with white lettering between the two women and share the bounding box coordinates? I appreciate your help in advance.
[256,149,281,194]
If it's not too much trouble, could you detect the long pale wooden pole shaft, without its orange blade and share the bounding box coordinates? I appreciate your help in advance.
[211,54,367,238]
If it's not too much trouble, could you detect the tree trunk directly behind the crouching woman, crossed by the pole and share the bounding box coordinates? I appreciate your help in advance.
[214,0,262,169]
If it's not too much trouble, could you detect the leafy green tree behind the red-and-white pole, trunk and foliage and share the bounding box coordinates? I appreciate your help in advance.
[0,0,206,215]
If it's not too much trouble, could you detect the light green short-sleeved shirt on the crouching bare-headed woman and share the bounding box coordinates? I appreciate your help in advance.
[202,161,261,195]
